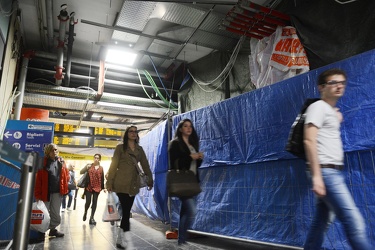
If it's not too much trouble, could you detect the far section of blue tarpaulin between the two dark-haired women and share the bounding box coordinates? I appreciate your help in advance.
[133,121,169,223]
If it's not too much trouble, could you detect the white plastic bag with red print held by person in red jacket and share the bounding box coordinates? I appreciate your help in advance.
[30,200,51,233]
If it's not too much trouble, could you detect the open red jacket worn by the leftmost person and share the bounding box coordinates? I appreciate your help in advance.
[34,157,70,201]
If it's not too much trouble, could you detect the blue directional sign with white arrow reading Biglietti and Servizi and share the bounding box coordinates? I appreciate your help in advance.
[3,120,55,155]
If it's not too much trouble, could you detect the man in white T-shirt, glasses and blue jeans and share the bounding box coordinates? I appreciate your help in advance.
[304,69,374,250]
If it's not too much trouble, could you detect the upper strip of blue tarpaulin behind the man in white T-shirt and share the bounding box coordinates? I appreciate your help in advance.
[173,51,375,167]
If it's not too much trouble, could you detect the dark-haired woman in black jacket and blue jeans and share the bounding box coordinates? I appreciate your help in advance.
[168,119,204,245]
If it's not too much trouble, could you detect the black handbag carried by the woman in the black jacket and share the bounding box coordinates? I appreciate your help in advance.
[167,169,202,197]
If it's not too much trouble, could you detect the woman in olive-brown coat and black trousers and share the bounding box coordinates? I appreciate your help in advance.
[106,126,154,249]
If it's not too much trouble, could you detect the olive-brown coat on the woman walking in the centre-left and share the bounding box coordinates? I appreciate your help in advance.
[106,144,154,196]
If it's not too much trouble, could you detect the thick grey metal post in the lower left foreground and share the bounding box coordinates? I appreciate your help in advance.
[12,152,39,250]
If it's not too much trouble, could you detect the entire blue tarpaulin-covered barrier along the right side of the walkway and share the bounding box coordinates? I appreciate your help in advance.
[139,51,375,249]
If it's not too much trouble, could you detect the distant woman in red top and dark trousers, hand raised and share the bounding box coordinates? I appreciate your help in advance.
[80,154,106,225]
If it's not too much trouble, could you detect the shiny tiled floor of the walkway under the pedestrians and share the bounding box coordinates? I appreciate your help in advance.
[5,190,302,250]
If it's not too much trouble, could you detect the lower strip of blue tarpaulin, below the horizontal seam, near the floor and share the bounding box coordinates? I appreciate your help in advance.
[194,150,375,249]
